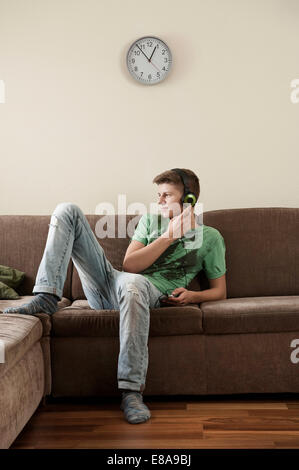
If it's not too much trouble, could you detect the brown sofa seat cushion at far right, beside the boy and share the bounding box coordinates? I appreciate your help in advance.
[200,295,299,334]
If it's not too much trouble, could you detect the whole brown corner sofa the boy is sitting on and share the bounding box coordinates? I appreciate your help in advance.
[0,207,299,448]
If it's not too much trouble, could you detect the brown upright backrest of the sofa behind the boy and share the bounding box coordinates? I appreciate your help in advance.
[0,207,299,300]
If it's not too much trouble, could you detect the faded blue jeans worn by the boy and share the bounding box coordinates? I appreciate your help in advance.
[32,202,162,391]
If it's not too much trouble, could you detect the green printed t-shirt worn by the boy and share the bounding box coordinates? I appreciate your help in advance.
[131,214,226,294]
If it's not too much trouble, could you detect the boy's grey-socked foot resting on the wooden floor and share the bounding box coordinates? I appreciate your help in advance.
[120,390,151,424]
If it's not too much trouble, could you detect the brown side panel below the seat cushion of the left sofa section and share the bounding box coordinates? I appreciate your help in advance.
[0,342,45,449]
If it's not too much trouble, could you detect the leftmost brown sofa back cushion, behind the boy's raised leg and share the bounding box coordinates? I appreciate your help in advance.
[0,215,71,298]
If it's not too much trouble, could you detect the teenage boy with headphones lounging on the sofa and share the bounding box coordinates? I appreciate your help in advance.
[3,169,226,424]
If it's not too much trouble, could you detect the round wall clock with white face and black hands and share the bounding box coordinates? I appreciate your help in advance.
[127,36,172,85]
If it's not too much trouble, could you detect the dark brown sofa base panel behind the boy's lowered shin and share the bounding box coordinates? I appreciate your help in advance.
[51,335,206,397]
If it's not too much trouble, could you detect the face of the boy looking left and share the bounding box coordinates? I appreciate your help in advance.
[158,183,183,219]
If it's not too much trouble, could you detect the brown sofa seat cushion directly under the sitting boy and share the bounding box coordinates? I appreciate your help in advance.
[51,300,202,337]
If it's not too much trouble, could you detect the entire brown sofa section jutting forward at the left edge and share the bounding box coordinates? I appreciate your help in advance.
[0,313,47,449]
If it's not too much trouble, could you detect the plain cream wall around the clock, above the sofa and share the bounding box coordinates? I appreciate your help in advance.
[0,0,299,214]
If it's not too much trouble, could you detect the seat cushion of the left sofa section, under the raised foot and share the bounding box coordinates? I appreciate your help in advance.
[0,313,43,376]
